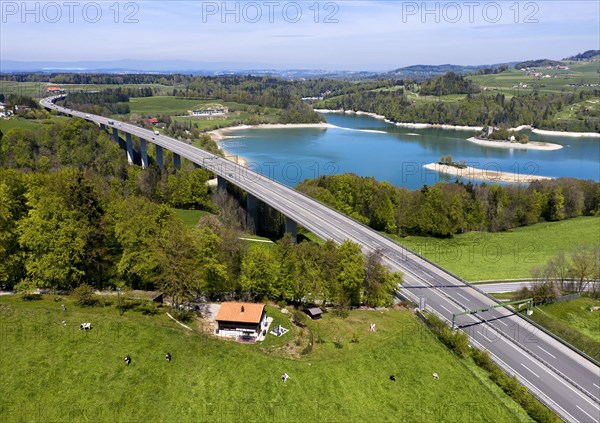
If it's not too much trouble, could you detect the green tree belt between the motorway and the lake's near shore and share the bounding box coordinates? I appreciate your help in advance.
[297,174,600,237]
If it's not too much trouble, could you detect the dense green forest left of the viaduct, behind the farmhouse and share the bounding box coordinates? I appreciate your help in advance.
[0,119,401,307]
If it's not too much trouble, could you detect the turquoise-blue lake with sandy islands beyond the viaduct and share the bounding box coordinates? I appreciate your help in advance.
[222,114,600,189]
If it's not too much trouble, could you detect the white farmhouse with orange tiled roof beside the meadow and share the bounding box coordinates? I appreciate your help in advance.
[215,302,268,341]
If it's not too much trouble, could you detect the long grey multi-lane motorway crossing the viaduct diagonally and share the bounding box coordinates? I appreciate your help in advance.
[41,96,600,423]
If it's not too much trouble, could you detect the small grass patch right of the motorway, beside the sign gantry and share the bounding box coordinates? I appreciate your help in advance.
[529,297,600,361]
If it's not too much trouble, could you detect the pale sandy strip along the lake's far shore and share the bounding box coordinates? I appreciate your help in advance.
[314,109,600,138]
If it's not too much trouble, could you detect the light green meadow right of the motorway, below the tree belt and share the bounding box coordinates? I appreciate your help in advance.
[396,217,600,281]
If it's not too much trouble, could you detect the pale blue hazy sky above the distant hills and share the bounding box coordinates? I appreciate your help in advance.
[0,0,600,71]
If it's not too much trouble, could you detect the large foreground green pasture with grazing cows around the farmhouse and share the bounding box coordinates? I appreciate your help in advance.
[0,296,530,422]
